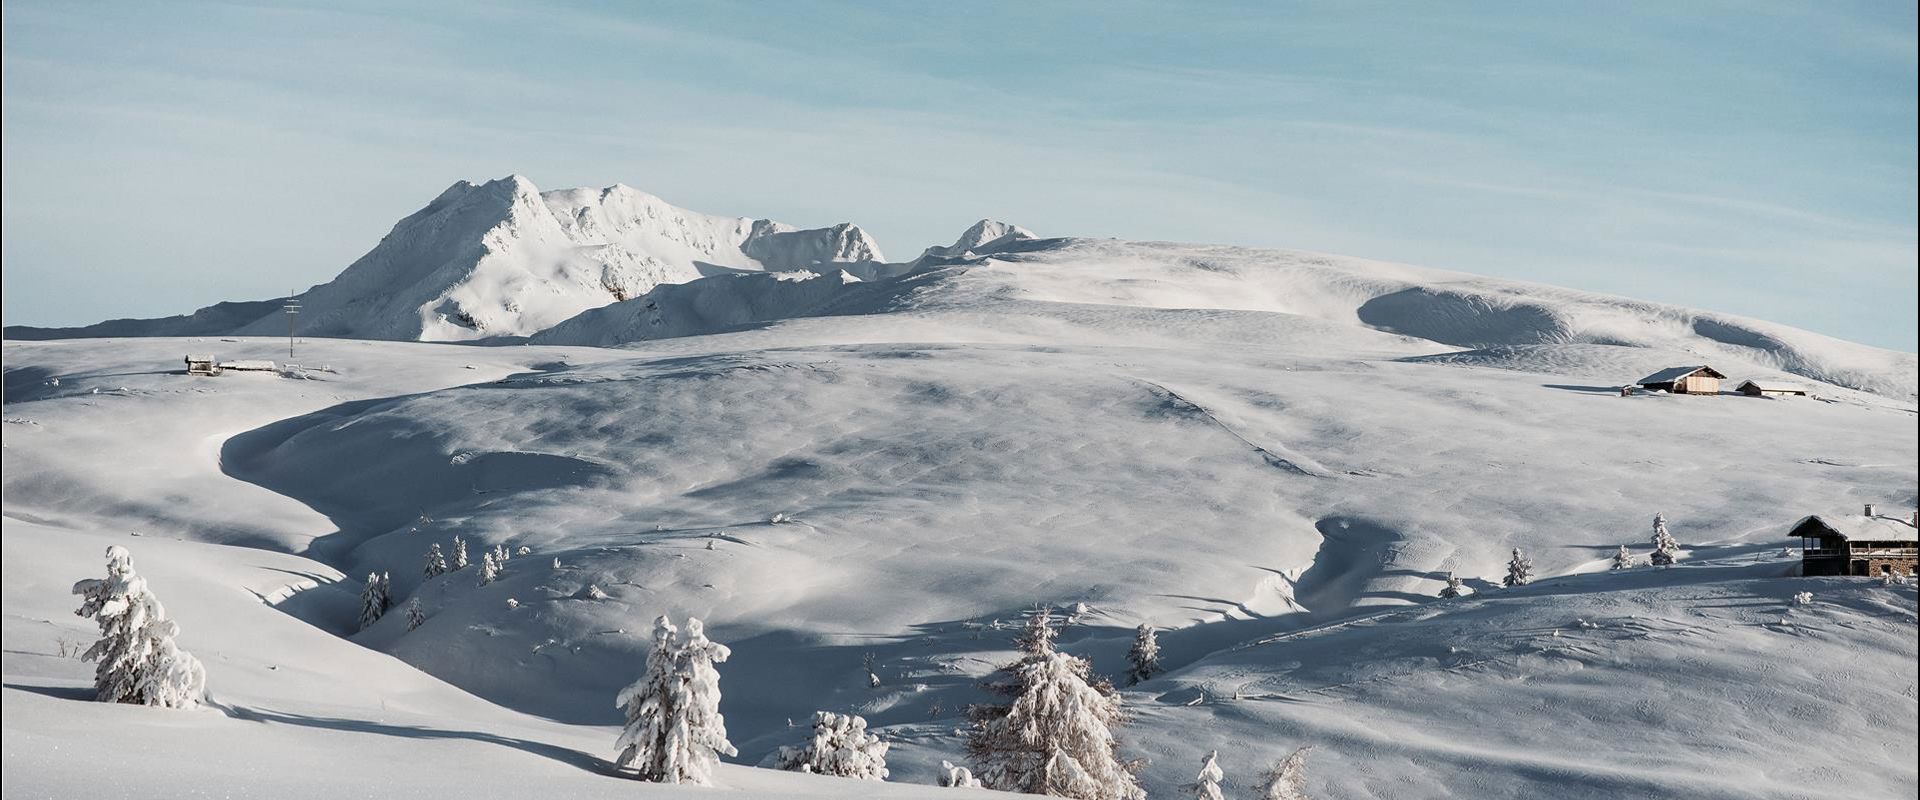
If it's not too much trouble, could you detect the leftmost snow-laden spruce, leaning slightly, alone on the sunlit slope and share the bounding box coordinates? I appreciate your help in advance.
[73,545,207,708]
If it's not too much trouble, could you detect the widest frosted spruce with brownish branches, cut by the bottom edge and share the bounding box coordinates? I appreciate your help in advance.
[966,606,1146,800]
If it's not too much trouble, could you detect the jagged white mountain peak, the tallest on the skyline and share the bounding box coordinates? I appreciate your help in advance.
[220,175,883,341]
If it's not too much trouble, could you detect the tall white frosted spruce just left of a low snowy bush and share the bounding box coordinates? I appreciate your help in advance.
[614,616,735,785]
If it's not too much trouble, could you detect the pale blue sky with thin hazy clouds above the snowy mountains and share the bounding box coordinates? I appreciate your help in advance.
[0,0,1920,351]
